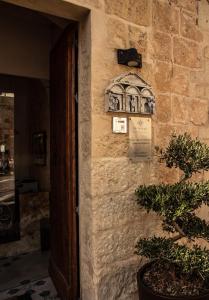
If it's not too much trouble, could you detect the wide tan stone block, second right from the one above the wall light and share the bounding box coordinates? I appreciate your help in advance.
[173,37,201,68]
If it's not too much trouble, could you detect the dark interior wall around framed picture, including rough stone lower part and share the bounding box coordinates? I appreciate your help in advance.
[0,75,50,257]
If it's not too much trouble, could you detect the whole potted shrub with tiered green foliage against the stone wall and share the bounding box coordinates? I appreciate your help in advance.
[136,133,209,300]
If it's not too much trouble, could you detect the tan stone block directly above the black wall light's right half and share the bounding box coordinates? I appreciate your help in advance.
[128,25,148,58]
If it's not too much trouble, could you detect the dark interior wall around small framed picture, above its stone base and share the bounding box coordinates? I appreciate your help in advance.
[0,75,50,191]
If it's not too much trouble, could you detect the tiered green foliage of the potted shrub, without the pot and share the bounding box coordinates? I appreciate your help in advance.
[136,133,209,282]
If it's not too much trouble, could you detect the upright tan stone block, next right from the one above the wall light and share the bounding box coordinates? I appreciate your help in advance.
[152,32,172,62]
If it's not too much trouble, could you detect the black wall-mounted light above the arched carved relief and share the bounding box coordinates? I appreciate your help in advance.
[117,48,142,68]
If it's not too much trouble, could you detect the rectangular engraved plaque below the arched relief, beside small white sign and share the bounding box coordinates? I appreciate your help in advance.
[129,117,152,159]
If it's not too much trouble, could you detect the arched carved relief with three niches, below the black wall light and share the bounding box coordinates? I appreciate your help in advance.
[105,73,155,115]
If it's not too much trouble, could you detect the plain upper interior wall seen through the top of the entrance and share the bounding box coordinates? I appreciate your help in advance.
[0,4,51,78]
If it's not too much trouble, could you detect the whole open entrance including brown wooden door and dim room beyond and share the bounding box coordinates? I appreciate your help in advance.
[0,2,78,300]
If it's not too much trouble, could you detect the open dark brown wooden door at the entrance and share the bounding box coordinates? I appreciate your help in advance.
[49,26,78,300]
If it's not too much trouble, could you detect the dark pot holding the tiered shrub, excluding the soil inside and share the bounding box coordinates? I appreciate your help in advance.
[137,262,209,300]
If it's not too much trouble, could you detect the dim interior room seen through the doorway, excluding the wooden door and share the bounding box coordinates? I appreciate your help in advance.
[0,2,69,300]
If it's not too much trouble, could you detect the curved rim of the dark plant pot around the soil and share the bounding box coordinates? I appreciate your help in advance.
[137,259,209,300]
